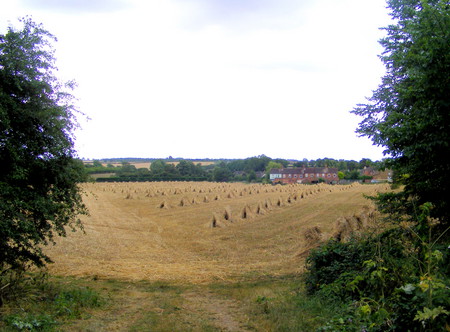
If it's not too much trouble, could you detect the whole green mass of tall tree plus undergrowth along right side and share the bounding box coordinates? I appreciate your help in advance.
[305,0,450,331]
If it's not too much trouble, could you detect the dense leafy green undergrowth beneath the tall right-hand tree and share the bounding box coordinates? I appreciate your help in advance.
[305,204,450,331]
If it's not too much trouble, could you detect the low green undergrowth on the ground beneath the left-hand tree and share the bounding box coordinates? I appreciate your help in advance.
[0,271,105,331]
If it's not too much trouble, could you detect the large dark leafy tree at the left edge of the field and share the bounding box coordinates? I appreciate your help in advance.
[0,18,87,272]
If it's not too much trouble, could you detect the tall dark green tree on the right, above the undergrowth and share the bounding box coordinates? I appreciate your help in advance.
[353,0,450,223]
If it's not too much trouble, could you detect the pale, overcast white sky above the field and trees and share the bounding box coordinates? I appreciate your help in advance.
[0,0,390,161]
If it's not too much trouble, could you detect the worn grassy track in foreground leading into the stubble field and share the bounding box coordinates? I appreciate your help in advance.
[65,281,255,332]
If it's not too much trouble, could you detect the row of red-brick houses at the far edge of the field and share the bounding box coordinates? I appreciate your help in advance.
[269,167,339,184]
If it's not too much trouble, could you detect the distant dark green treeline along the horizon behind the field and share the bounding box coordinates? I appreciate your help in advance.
[85,155,383,182]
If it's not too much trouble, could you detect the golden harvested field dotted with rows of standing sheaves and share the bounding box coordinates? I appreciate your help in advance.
[46,182,389,283]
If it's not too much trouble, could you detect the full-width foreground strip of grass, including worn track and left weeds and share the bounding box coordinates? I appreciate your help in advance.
[0,275,338,332]
